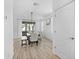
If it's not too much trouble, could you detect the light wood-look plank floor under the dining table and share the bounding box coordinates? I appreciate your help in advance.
[13,39,58,59]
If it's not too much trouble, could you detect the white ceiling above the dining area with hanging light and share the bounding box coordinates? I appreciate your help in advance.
[13,0,53,16]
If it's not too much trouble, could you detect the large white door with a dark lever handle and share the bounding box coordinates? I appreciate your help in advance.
[54,2,75,59]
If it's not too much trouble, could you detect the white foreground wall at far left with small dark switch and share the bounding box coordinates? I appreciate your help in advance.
[4,0,13,59]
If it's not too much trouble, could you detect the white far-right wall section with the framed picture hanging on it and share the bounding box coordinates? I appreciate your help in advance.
[43,15,53,41]
